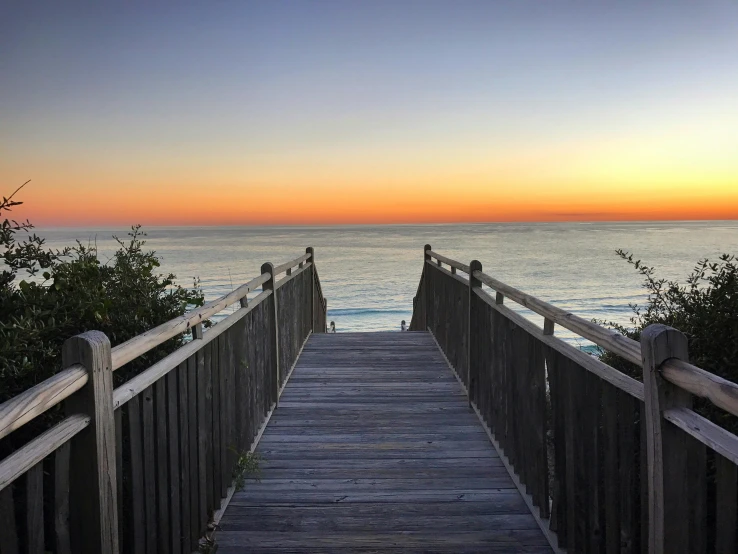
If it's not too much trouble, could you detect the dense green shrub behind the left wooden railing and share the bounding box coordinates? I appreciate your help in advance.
[0,183,204,442]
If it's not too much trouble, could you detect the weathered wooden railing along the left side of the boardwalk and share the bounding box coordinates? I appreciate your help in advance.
[0,248,326,554]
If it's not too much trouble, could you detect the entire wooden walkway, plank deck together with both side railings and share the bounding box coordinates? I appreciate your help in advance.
[0,245,738,554]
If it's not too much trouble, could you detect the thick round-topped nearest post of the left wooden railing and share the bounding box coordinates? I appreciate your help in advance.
[62,331,118,554]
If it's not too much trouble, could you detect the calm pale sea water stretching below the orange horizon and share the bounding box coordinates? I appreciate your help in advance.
[39,221,738,343]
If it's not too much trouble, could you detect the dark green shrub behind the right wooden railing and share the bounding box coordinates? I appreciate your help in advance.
[600,250,738,434]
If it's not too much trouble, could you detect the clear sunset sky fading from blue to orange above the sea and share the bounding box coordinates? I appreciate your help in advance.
[0,0,738,226]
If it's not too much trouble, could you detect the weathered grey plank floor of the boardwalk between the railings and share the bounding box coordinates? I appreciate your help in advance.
[216,332,551,554]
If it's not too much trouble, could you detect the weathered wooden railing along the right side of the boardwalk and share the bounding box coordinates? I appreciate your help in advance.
[410,245,738,553]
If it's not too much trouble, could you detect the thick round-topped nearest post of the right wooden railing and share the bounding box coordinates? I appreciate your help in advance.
[641,324,692,554]
